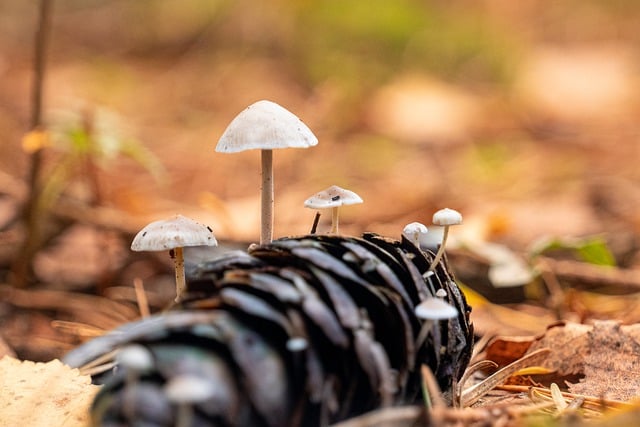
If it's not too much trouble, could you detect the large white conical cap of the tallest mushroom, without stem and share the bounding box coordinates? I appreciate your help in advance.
[216,100,318,153]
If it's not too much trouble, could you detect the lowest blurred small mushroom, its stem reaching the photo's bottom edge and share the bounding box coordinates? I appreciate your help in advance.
[164,374,215,427]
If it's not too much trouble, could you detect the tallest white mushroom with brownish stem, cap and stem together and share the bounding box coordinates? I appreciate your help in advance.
[216,100,318,244]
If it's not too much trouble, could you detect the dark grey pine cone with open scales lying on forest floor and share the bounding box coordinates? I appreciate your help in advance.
[66,233,473,427]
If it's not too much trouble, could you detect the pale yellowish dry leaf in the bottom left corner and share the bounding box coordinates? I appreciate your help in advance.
[0,356,99,427]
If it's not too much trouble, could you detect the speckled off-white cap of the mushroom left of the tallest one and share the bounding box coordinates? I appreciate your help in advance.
[131,215,218,252]
